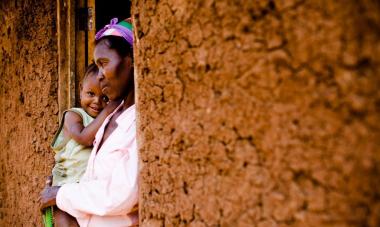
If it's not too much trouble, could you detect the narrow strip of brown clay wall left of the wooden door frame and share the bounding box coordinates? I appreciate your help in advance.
[0,0,58,226]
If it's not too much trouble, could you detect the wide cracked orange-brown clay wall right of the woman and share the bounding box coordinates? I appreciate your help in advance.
[133,0,380,227]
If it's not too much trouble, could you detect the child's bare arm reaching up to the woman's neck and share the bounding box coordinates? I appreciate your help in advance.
[64,101,120,146]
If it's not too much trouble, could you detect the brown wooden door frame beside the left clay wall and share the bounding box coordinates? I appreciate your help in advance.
[57,0,95,118]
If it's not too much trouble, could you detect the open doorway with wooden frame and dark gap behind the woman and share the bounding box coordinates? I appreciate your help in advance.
[57,0,131,115]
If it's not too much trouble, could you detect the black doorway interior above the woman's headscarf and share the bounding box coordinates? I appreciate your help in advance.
[95,0,131,31]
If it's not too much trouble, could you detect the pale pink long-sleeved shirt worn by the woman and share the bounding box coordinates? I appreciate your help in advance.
[56,103,138,227]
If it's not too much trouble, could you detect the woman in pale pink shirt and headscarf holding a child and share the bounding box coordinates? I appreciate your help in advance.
[41,19,138,226]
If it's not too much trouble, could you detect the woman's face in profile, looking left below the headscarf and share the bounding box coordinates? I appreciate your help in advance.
[94,40,133,100]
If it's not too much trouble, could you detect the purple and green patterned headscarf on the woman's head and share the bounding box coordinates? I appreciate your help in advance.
[95,18,133,47]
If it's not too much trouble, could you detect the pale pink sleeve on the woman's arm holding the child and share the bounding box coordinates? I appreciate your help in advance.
[56,141,138,218]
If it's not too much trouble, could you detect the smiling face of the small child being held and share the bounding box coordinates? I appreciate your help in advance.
[80,75,107,117]
